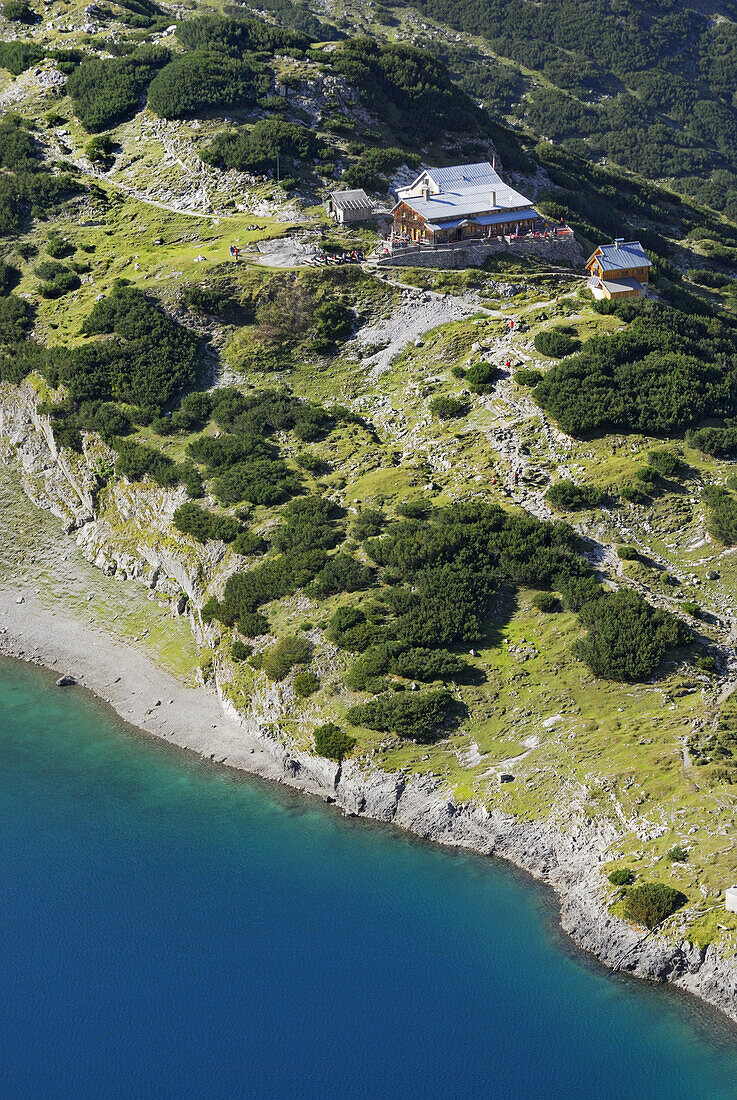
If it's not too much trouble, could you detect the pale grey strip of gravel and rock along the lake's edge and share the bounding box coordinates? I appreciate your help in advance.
[0,587,737,1022]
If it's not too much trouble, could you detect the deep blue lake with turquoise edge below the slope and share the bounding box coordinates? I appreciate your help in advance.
[0,662,737,1100]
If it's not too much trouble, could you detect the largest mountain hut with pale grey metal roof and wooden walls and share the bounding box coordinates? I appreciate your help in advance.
[392,161,538,244]
